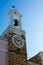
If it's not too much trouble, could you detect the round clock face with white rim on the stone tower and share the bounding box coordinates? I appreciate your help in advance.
[12,35,24,48]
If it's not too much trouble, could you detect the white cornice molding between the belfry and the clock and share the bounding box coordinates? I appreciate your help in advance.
[1,26,26,37]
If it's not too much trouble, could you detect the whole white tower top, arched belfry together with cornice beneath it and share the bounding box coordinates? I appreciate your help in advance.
[2,6,25,38]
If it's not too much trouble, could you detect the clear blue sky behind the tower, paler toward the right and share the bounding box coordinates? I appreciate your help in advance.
[0,0,43,58]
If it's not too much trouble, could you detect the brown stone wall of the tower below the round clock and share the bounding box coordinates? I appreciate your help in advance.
[8,33,27,65]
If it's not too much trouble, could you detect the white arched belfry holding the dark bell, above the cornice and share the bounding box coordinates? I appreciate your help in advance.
[9,6,22,30]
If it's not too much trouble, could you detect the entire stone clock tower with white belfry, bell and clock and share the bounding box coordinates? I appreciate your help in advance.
[2,6,27,65]
